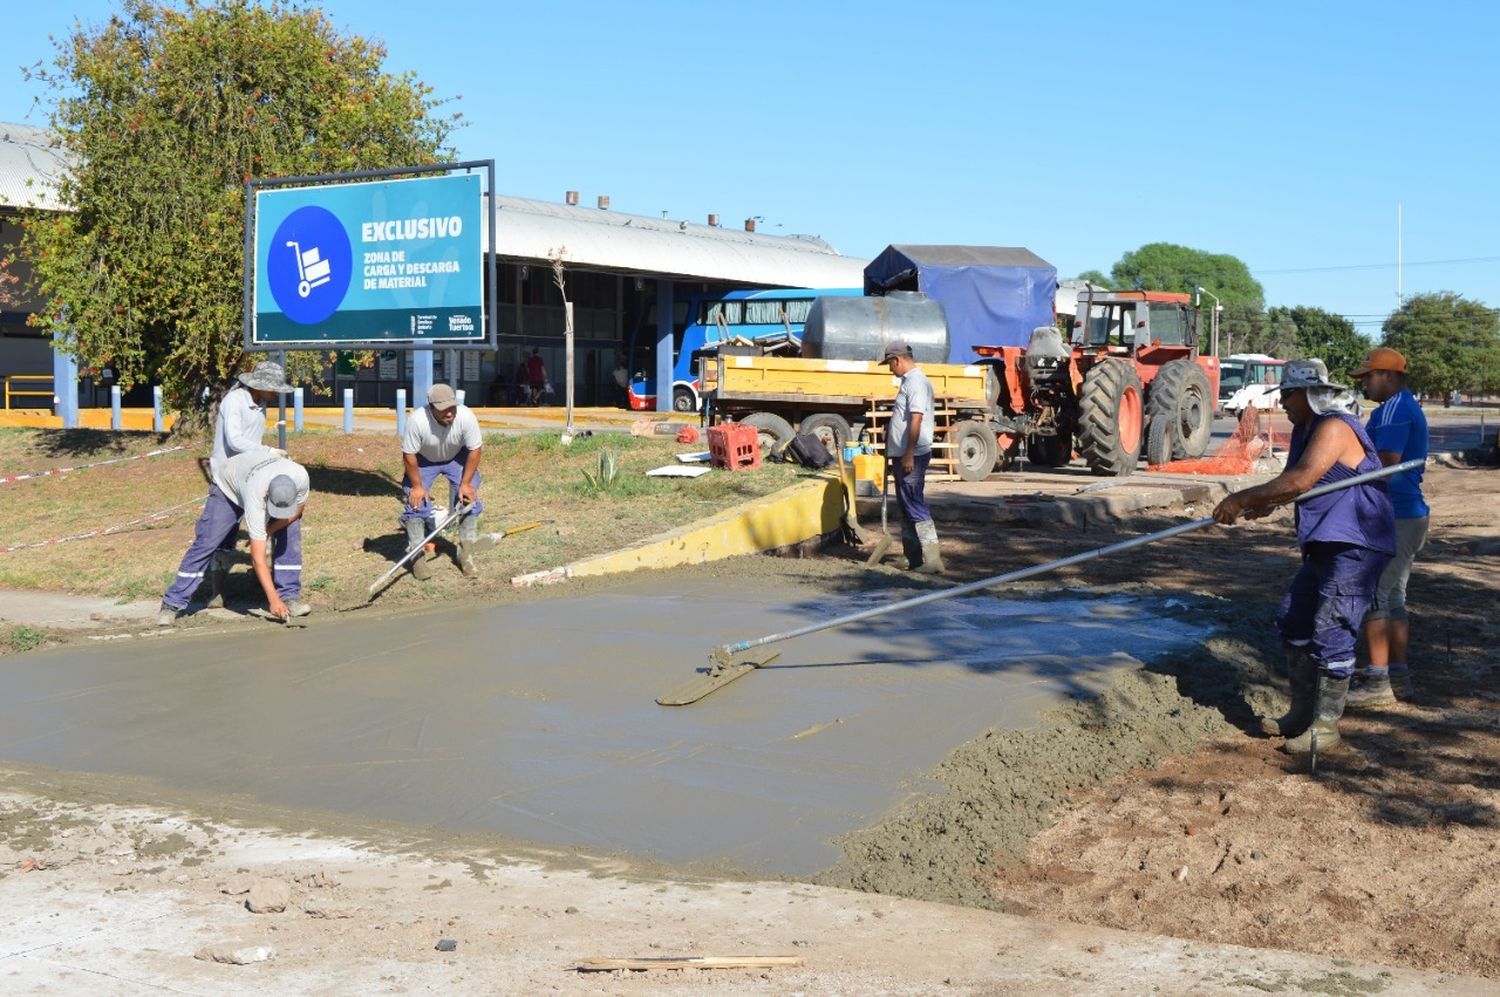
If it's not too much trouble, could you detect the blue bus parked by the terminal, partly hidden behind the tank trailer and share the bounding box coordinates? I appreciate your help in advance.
[627,288,864,412]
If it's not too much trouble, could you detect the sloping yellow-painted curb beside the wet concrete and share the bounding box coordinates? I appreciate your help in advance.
[510,471,845,588]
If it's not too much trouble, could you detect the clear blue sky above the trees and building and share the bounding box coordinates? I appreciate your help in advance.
[0,0,1500,333]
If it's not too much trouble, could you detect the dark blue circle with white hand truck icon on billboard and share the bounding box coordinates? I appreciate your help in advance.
[266,204,354,325]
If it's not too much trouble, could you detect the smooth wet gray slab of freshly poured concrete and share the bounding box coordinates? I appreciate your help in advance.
[0,579,1203,874]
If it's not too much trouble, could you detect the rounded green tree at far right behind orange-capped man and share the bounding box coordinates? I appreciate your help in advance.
[1382,291,1500,394]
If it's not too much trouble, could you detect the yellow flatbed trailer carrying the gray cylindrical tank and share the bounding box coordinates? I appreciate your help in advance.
[702,354,999,481]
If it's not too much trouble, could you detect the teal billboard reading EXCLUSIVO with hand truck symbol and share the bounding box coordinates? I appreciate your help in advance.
[251,174,486,346]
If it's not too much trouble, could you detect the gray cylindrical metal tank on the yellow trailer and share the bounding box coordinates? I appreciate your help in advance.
[803,291,948,363]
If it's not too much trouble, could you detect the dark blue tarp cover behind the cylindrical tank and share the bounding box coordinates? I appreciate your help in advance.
[864,246,1058,363]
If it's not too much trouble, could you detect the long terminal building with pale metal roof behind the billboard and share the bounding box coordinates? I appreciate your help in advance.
[0,123,867,409]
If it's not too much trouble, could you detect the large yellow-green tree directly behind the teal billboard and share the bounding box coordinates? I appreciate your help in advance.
[24,0,458,409]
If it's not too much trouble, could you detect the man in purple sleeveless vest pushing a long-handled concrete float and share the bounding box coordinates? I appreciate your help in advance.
[1214,360,1397,754]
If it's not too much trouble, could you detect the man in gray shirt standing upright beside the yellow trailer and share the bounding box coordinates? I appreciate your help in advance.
[881,339,944,574]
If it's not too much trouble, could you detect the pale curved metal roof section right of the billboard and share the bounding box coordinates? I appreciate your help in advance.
[495,196,869,288]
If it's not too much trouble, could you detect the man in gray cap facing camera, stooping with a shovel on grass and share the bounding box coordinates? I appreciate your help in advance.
[401,384,485,579]
